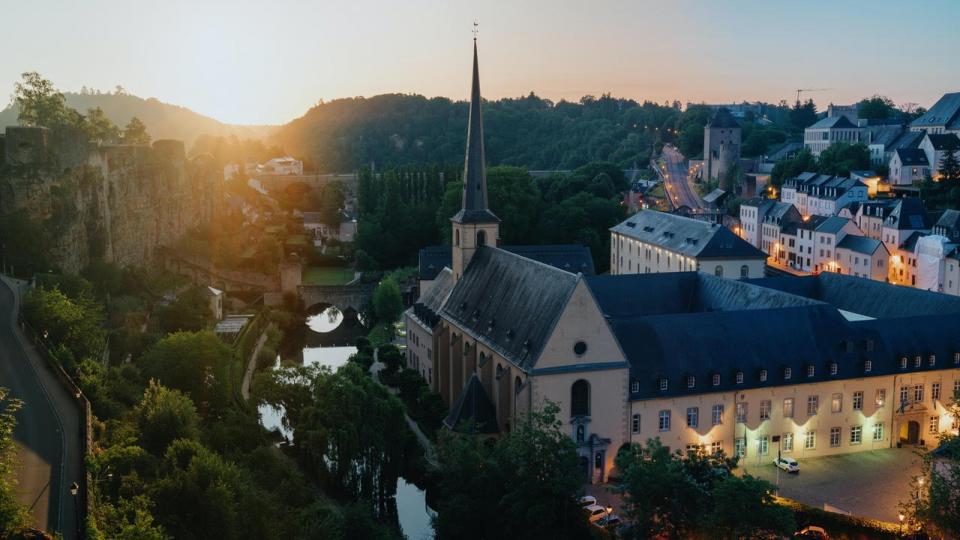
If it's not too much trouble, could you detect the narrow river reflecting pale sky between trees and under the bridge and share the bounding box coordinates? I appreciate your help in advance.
[259,307,433,540]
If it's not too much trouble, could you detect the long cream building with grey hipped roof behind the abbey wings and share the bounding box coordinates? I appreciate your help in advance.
[610,210,767,278]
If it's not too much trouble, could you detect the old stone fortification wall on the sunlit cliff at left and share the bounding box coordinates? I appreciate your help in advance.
[0,127,223,272]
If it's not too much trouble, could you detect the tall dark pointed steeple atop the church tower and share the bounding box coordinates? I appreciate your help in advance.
[452,38,500,223]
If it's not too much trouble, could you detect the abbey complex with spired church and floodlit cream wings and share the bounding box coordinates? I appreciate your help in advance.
[405,40,960,482]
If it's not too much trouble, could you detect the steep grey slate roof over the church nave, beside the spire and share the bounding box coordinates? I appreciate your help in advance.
[442,246,580,369]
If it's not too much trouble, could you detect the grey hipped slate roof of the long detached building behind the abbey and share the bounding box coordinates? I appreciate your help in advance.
[610,210,767,259]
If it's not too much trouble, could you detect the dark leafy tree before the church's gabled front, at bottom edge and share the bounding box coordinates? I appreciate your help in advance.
[434,403,590,539]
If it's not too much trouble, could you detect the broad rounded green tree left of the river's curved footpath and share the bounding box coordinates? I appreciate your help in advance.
[138,330,233,414]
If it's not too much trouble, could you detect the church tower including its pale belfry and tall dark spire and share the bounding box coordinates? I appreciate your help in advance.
[450,38,500,280]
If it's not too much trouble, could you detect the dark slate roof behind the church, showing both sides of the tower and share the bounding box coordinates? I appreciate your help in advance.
[420,244,596,280]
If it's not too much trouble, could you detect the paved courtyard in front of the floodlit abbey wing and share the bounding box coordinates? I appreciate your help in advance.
[737,447,920,523]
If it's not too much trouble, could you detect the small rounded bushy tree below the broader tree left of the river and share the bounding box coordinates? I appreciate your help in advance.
[133,380,200,455]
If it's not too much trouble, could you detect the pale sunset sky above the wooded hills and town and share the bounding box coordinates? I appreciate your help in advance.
[0,0,960,124]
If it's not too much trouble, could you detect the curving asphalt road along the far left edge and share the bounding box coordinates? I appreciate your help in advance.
[0,278,83,539]
